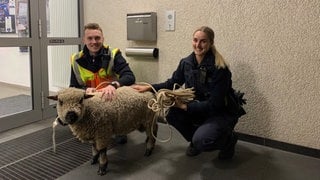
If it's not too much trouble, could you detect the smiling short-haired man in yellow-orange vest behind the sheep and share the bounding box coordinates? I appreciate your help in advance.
[70,23,135,144]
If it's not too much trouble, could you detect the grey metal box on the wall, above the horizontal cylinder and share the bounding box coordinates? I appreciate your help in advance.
[127,12,157,41]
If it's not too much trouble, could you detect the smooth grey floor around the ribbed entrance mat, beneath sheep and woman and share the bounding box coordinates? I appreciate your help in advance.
[0,120,320,180]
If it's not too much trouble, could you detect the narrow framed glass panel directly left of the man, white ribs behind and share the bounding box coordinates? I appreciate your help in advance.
[40,0,83,118]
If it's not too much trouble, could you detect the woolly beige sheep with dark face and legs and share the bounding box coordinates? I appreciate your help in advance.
[48,86,158,175]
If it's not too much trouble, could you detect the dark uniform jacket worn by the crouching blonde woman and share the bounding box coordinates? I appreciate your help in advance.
[153,51,232,115]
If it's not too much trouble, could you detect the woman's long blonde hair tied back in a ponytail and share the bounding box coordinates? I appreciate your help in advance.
[193,26,229,69]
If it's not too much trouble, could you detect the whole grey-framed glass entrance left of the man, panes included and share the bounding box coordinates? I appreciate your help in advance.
[0,0,83,132]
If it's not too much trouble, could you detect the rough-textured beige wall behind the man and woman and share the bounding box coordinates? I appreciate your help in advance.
[85,0,320,149]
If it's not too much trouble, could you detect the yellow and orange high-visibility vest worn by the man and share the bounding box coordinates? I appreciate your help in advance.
[71,45,119,88]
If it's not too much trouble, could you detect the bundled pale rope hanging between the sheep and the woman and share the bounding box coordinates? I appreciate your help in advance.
[137,82,195,142]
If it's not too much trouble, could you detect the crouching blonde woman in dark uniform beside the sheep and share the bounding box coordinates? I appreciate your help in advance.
[132,26,238,159]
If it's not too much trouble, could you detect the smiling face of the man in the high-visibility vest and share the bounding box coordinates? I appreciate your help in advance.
[82,29,104,55]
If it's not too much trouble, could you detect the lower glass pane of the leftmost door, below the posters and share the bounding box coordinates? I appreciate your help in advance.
[0,47,32,118]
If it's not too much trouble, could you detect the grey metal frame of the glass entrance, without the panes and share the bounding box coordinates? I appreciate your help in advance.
[0,0,84,132]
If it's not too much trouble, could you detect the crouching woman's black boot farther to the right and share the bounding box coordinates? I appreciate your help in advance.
[218,132,238,160]
